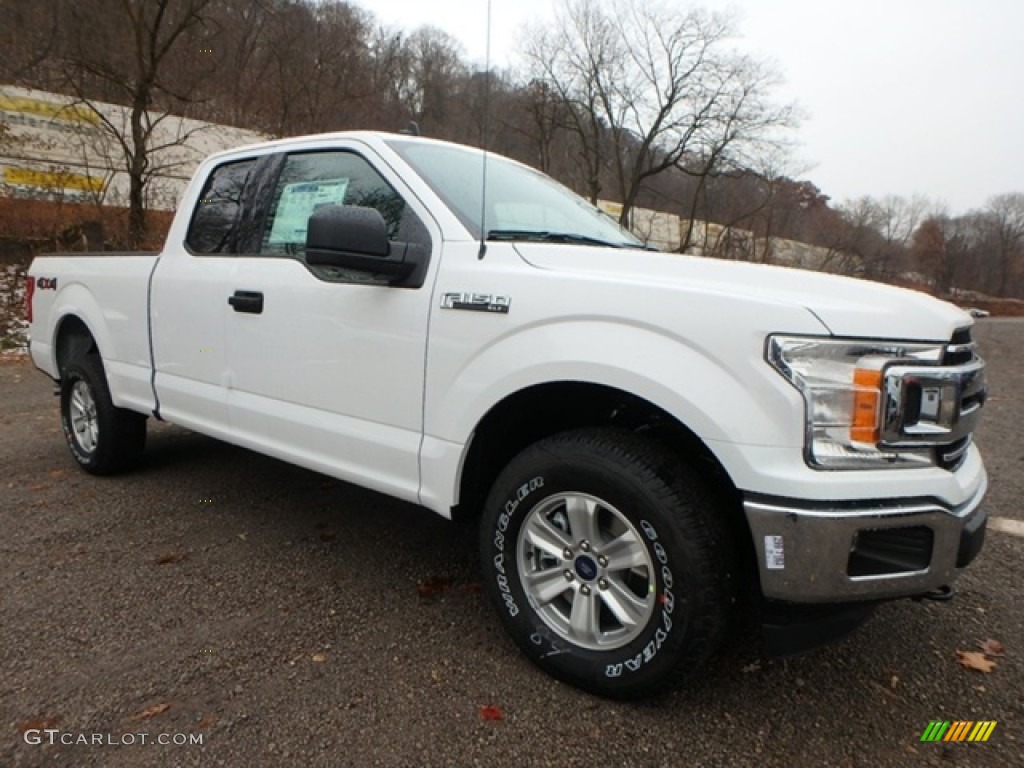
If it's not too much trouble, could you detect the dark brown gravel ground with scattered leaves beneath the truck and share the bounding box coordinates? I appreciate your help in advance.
[0,321,1024,767]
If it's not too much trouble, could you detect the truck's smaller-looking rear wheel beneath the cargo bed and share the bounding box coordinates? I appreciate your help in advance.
[60,354,145,475]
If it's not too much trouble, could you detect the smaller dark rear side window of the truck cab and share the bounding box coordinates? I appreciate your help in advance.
[185,160,256,253]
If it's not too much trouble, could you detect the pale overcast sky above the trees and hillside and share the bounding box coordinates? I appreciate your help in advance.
[354,0,1024,213]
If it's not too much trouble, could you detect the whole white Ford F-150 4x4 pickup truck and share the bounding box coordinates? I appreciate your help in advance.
[28,133,987,698]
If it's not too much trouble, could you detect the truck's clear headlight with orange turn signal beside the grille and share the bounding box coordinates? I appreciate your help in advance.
[767,336,943,469]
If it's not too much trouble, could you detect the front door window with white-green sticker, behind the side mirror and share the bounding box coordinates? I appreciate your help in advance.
[260,151,429,259]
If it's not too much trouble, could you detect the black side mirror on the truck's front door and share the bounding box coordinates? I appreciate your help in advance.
[306,205,416,282]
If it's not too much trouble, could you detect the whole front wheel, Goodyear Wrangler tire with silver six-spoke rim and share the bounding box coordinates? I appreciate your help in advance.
[480,430,733,699]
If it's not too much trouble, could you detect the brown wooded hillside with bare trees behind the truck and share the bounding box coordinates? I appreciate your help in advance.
[0,0,1024,305]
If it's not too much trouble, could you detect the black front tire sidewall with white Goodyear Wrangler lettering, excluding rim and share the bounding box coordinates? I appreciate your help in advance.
[481,455,699,697]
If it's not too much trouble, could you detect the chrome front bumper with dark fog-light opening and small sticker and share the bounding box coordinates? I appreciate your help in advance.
[743,479,987,603]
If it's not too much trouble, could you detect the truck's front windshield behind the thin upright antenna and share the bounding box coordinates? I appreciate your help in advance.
[388,139,643,248]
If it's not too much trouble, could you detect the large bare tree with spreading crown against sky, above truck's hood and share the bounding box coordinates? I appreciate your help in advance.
[526,0,797,224]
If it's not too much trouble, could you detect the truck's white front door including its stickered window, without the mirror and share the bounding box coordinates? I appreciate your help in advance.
[226,143,440,501]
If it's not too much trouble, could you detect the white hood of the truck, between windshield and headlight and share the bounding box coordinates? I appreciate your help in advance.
[515,243,973,341]
